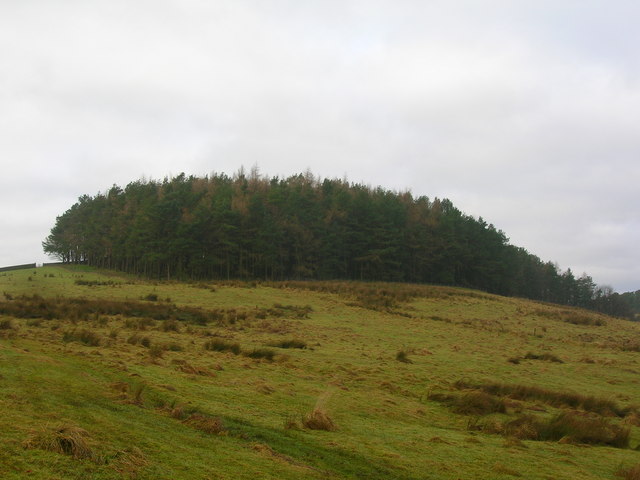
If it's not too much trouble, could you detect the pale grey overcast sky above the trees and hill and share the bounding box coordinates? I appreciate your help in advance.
[0,0,640,292]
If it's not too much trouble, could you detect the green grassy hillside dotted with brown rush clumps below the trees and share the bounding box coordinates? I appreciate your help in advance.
[0,267,640,480]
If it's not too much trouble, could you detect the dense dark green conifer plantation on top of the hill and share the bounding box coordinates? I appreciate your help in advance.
[43,169,628,315]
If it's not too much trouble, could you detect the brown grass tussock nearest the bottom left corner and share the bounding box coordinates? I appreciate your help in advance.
[22,425,98,461]
